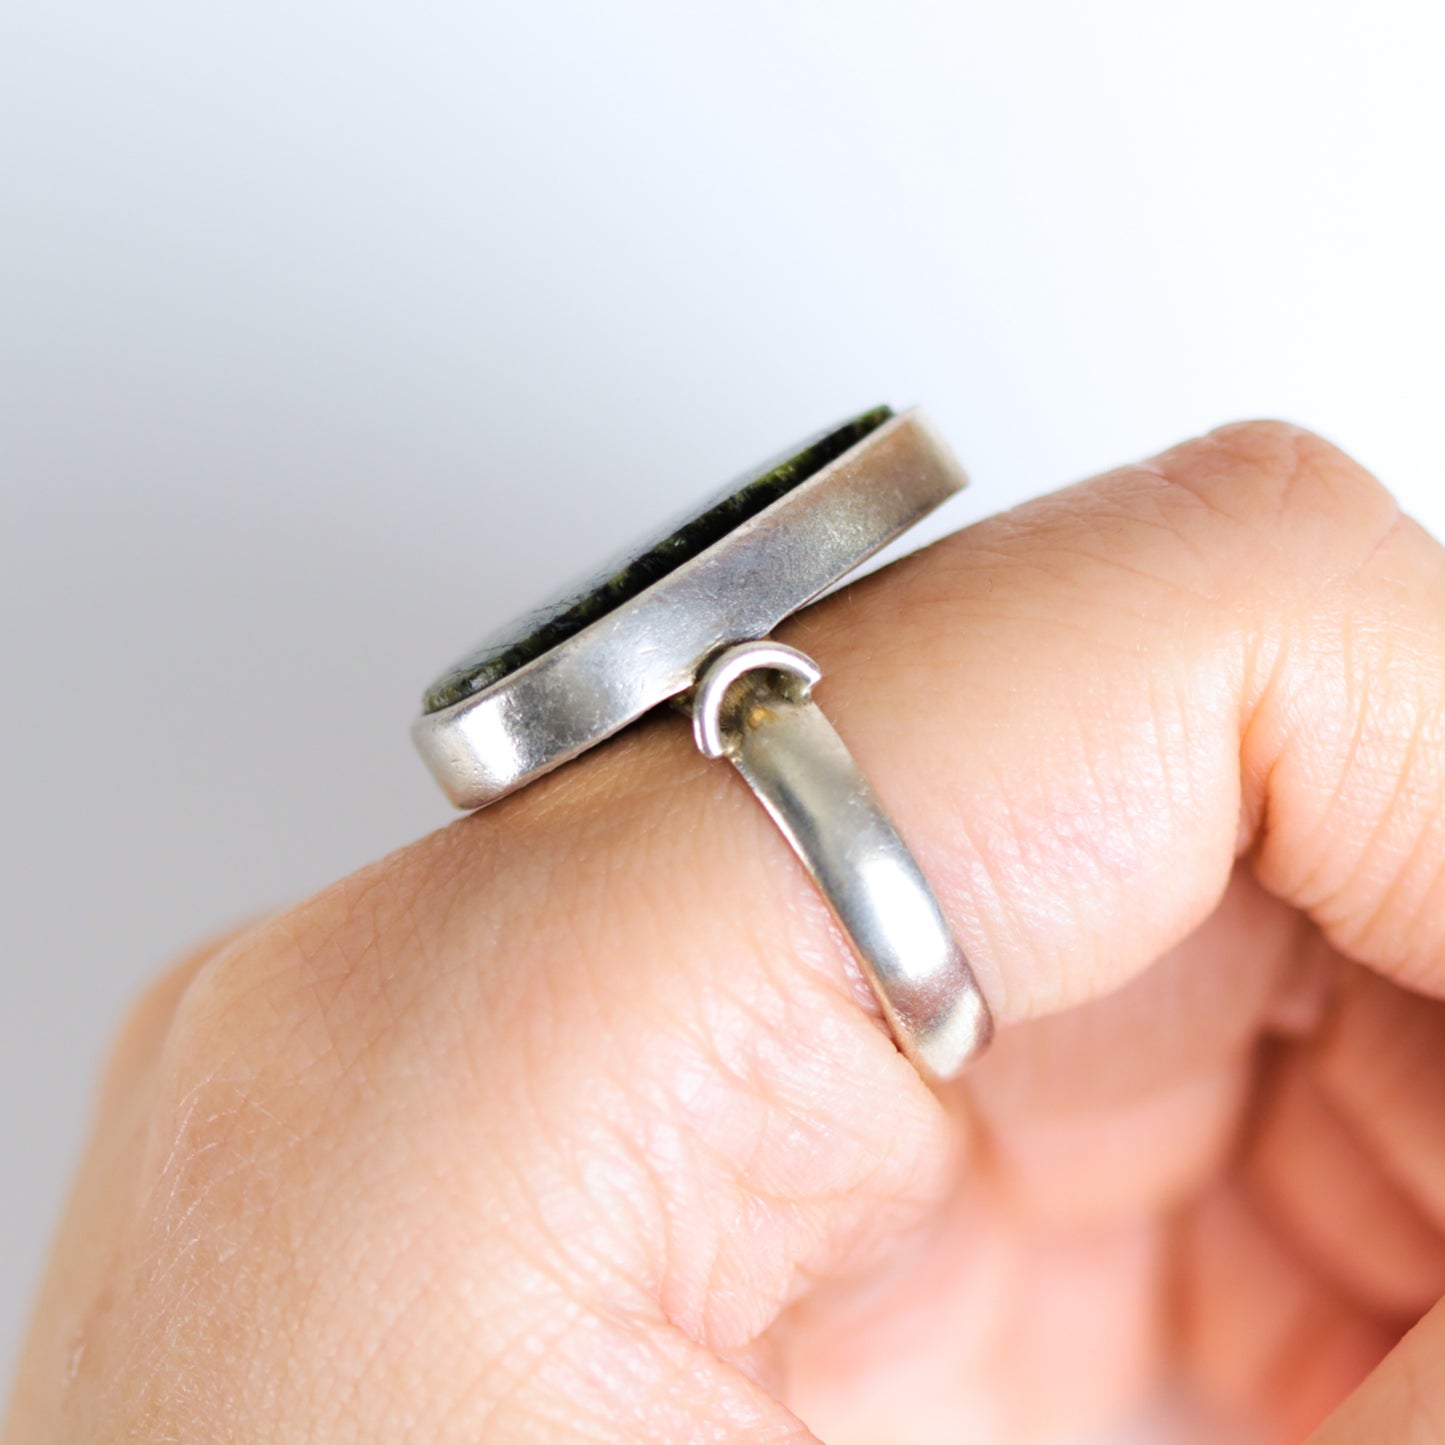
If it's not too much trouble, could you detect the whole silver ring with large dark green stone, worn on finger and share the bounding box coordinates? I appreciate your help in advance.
[412,406,993,1082]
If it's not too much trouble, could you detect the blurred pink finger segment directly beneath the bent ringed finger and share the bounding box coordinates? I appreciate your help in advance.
[957,870,1318,1230]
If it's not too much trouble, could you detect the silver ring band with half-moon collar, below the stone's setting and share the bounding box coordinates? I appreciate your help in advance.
[692,639,993,1081]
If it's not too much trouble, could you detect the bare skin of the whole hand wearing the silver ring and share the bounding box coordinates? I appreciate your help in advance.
[3,423,1445,1445]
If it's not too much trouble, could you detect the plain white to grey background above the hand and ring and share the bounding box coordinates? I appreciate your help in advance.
[0,0,1445,1421]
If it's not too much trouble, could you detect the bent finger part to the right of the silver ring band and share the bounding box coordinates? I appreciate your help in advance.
[795,425,1445,1020]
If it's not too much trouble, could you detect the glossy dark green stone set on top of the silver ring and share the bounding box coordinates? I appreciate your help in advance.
[422,406,893,712]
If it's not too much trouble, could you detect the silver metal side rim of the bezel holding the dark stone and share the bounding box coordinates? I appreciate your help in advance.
[412,410,967,808]
